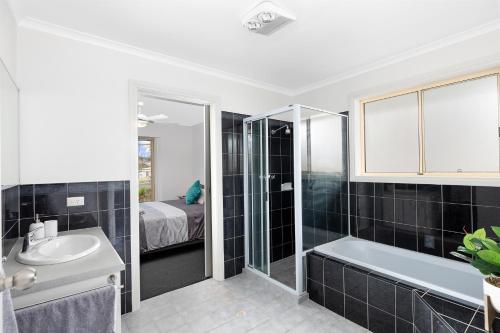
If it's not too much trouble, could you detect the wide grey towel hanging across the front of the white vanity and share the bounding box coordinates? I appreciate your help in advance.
[16,286,116,333]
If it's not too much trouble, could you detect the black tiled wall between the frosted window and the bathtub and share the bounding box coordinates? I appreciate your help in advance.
[350,182,500,260]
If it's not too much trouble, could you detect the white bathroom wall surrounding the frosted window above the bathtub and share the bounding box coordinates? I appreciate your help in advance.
[294,26,500,185]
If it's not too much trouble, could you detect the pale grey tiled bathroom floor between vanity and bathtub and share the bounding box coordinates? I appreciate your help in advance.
[122,272,367,333]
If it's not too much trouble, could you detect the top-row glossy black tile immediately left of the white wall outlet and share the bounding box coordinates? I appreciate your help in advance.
[35,184,68,215]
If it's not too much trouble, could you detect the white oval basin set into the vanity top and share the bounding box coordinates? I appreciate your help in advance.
[16,235,101,266]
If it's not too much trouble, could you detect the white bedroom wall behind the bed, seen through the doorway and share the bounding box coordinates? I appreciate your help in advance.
[138,122,204,201]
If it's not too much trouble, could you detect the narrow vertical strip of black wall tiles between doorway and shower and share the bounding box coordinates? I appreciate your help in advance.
[222,112,248,278]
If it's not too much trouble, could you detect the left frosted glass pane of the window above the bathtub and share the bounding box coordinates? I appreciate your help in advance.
[365,93,419,173]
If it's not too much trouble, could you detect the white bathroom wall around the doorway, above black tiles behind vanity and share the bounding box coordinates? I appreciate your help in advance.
[19,28,289,183]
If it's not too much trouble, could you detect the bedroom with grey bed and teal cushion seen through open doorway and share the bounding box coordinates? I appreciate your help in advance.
[137,93,210,300]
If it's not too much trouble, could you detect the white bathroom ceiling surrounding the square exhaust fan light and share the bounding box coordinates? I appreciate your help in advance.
[10,0,500,90]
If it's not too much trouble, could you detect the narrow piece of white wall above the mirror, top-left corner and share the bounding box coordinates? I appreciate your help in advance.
[0,0,17,80]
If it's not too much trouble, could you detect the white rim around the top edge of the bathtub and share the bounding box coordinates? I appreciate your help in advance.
[314,236,484,306]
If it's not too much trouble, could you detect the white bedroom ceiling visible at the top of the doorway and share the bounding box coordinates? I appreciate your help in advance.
[140,96,204,126]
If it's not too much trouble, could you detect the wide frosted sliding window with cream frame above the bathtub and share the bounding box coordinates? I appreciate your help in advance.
[361,69,500,176]
